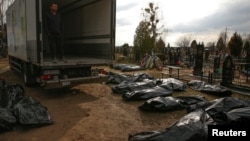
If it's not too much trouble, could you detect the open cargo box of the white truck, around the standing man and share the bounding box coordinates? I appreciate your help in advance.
[7,0,115,65]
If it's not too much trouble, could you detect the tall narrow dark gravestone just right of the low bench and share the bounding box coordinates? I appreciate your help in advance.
[193,44,204,76]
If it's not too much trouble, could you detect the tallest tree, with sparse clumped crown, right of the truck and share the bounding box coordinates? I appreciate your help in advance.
[133,2,166,57]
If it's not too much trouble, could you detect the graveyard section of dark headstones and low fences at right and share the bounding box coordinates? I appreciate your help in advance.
[159,44,250,94]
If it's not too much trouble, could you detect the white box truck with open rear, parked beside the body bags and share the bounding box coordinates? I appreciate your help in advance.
[6,0,116,88]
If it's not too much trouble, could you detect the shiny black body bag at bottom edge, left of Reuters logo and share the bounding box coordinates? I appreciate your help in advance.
[128,109,207,141]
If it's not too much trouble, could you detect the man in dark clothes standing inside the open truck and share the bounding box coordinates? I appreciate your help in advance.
[45,2,65,62]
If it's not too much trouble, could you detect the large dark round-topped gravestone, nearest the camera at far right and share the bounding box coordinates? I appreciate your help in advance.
[221,55,234,85]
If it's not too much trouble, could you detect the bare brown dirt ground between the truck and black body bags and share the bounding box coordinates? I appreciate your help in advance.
[0,58,250,141]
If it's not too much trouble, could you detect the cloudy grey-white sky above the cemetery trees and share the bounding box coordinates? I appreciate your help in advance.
[116,0,250,46]
